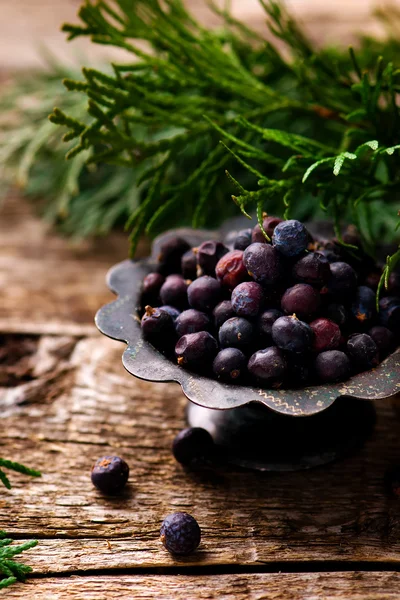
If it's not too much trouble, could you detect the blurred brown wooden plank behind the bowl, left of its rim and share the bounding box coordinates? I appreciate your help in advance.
[0,198,138,335]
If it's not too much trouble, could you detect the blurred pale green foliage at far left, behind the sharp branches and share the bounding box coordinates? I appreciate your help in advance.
[0,62,144,238]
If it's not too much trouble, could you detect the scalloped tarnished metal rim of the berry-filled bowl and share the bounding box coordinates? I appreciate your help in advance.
[96,229,400,417]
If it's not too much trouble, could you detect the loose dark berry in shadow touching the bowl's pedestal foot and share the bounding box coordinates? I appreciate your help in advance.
[172,427,214,465]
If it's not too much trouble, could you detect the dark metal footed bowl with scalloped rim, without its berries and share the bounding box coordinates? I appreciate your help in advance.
[95,229,400,470]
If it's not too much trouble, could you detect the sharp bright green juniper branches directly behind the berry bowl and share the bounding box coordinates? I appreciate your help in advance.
[50,0,400,272]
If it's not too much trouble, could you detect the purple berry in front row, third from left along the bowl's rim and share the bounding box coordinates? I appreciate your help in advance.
[247,346,287,388]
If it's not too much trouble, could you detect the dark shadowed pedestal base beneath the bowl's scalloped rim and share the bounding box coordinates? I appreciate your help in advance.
[187,397,375,471]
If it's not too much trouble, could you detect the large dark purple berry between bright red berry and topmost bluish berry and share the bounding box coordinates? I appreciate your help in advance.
[243,243,281,285]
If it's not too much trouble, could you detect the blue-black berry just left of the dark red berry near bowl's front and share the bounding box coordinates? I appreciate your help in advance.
[272,317,313,353]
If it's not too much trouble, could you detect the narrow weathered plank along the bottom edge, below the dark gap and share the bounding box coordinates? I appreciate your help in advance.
[7,572,400,600]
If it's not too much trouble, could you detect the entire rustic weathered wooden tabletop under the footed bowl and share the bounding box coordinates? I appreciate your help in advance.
[0,198,400,600]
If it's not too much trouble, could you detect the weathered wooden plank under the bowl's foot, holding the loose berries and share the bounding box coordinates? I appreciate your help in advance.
[0,336,400,573]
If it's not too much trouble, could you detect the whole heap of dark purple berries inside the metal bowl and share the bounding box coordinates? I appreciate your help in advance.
[141,217,400,388]
